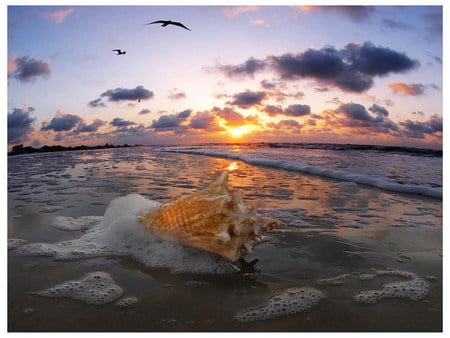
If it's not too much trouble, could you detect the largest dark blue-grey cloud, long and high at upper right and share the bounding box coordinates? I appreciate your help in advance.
[217,42,419,93]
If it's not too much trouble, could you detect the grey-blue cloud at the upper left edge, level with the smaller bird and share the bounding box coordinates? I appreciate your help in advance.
[8,56,50,82]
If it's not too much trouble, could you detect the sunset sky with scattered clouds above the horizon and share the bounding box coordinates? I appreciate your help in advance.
[5,4,443,149]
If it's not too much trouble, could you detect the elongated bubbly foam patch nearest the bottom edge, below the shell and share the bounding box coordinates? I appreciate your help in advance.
[236,287,325,322]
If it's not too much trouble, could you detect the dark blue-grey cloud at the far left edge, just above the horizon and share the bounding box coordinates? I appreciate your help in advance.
[8,107,36,144]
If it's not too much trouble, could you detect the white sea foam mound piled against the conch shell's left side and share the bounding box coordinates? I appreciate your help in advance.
[15,194,236,274]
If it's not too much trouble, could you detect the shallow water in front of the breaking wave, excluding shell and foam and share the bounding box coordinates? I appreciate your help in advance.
[8,148,442,332]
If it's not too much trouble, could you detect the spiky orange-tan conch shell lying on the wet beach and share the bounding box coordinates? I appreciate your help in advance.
[140,172,280,261]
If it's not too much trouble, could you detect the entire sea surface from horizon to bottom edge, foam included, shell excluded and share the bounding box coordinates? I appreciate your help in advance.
[8,144,443,332]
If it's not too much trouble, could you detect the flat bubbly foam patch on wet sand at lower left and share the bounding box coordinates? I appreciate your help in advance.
[36,271,123,305]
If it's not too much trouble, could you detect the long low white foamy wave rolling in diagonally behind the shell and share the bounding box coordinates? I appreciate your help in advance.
[157,147,442,199]
